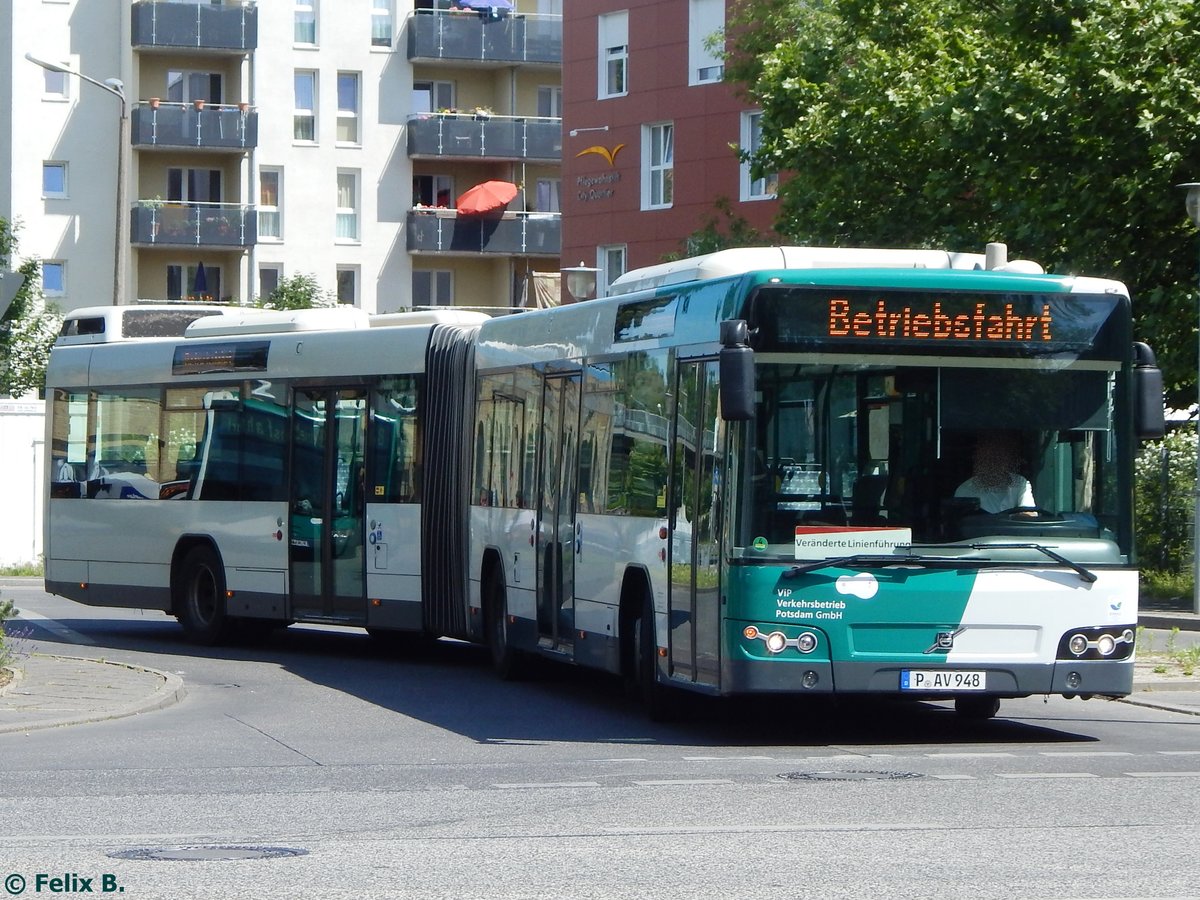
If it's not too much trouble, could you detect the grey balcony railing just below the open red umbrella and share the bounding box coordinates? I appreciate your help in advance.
[408,209,563,258]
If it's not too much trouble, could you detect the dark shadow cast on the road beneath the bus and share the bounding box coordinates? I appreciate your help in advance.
[28,612,1098,748]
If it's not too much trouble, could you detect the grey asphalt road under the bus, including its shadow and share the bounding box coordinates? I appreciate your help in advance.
[0,587,1200,900]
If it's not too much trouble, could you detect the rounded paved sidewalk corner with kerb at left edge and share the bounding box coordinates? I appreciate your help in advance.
[0,653,186,734]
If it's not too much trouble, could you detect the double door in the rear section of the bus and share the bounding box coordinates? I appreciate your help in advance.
[289,388,367,624]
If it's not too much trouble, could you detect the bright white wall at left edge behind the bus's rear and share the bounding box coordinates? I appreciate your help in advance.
[0,400,46,565]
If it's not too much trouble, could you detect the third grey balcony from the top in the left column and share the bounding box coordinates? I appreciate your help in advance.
[130,200,258,250]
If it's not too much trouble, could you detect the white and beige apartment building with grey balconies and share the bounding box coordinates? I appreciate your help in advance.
[0,0,562,312]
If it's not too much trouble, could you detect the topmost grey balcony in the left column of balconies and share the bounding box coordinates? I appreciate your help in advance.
[131,0,258,54]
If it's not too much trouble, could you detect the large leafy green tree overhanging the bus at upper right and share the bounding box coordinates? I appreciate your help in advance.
[727,0,1200,407]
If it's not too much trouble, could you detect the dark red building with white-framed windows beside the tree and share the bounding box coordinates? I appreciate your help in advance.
[563,0,778,292]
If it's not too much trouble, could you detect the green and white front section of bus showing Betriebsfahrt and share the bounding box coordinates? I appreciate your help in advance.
[469,247,1162,718]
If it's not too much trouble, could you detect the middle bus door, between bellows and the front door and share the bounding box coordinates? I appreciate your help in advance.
[538,373,581,650]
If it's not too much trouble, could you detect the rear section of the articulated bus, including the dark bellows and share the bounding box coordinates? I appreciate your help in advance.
[46,307,486,643]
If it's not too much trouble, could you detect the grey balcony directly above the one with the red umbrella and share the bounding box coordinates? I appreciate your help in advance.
[408,113,563,162]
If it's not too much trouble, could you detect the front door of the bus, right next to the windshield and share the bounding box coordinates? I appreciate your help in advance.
[667,360,725,685]
